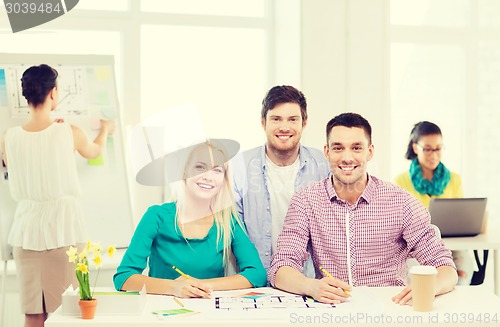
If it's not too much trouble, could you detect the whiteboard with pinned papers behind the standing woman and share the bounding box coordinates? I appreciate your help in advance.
[0,53,133,260]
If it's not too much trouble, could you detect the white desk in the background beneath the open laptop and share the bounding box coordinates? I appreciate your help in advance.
[443,226,500,295]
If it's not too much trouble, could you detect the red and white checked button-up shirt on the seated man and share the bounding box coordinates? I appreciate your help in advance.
[268,176,455,286]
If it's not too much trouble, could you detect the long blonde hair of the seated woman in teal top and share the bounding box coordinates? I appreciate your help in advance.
[172,140,245,268]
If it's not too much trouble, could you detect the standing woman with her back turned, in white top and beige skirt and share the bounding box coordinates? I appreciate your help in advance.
[3,65,114,327]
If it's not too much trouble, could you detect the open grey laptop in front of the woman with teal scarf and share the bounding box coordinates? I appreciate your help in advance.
[429,198,487,237]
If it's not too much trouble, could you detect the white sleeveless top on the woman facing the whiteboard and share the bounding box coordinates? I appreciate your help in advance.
[5,123,86,251]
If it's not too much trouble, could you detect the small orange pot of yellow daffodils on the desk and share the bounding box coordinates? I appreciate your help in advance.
[66,241,116,319]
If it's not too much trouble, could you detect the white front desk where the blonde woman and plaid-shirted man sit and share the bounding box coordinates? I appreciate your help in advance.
[45,286,500,327]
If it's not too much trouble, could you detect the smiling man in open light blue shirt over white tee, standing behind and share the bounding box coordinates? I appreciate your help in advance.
[233,85,330,273]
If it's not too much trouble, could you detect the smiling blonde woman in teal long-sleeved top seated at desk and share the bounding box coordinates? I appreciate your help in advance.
[113,140,267,298]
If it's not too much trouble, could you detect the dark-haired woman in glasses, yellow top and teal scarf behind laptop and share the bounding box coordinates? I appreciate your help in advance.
[395,121,474,285]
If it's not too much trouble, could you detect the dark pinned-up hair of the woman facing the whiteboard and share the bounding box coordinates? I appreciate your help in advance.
[21,64,58,107]
